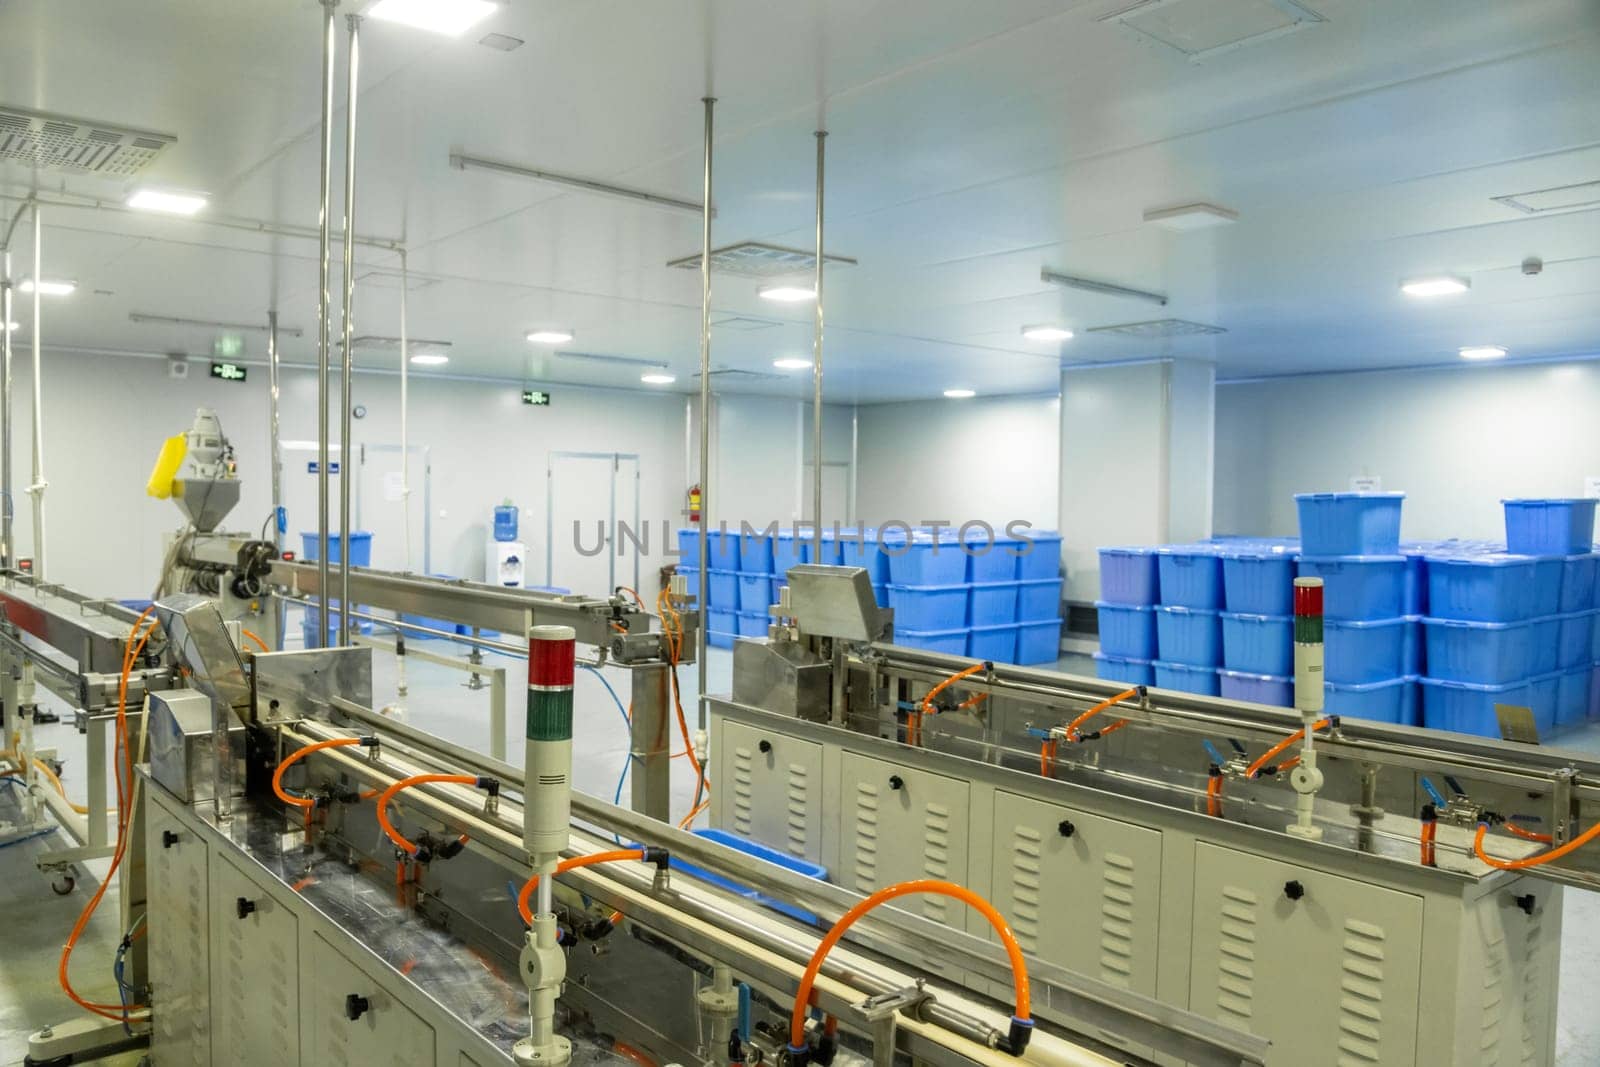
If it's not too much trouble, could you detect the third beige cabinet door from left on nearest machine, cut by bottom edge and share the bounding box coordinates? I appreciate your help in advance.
[304,934,438,1067]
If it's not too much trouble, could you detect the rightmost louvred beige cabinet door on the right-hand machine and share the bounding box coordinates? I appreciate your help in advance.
[1189,843,1445,1067]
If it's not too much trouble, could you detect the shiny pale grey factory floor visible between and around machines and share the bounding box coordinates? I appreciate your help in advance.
[0,641,1600,1067]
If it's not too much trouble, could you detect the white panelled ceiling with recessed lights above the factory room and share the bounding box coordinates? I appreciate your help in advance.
[0,0,1600,402]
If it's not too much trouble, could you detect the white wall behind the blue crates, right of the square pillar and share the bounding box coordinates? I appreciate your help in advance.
[1216,362,1600,539]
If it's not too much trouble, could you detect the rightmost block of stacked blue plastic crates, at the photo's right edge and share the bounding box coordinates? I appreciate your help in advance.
[1422,499,1597,737]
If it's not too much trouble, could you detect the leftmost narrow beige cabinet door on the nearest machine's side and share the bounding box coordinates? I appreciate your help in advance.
[144,789,211,1067]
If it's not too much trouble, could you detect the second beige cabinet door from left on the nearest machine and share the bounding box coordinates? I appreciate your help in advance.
[211,853,300,1067]
